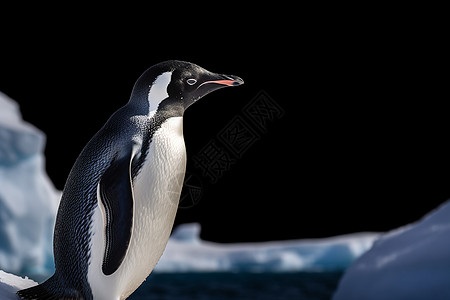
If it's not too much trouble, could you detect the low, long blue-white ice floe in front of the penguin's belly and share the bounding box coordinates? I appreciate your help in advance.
[155,223,379,272]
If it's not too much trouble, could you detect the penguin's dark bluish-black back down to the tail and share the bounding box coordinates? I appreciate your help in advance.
[18,106,134,300]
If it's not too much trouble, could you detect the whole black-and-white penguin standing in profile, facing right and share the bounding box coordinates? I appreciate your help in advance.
[17,60,244,300]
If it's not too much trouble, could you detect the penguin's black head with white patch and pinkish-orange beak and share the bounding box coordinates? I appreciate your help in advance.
[130,60,244,116]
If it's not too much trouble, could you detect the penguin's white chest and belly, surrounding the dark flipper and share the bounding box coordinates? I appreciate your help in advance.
[88,117,186,300]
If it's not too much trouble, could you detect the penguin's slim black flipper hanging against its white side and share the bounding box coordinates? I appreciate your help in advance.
[99,150,134,275]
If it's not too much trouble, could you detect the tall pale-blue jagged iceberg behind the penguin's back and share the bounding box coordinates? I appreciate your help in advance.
[0,93,60,274]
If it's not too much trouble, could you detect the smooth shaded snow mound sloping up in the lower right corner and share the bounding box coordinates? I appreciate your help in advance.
[333,201,450,300]
